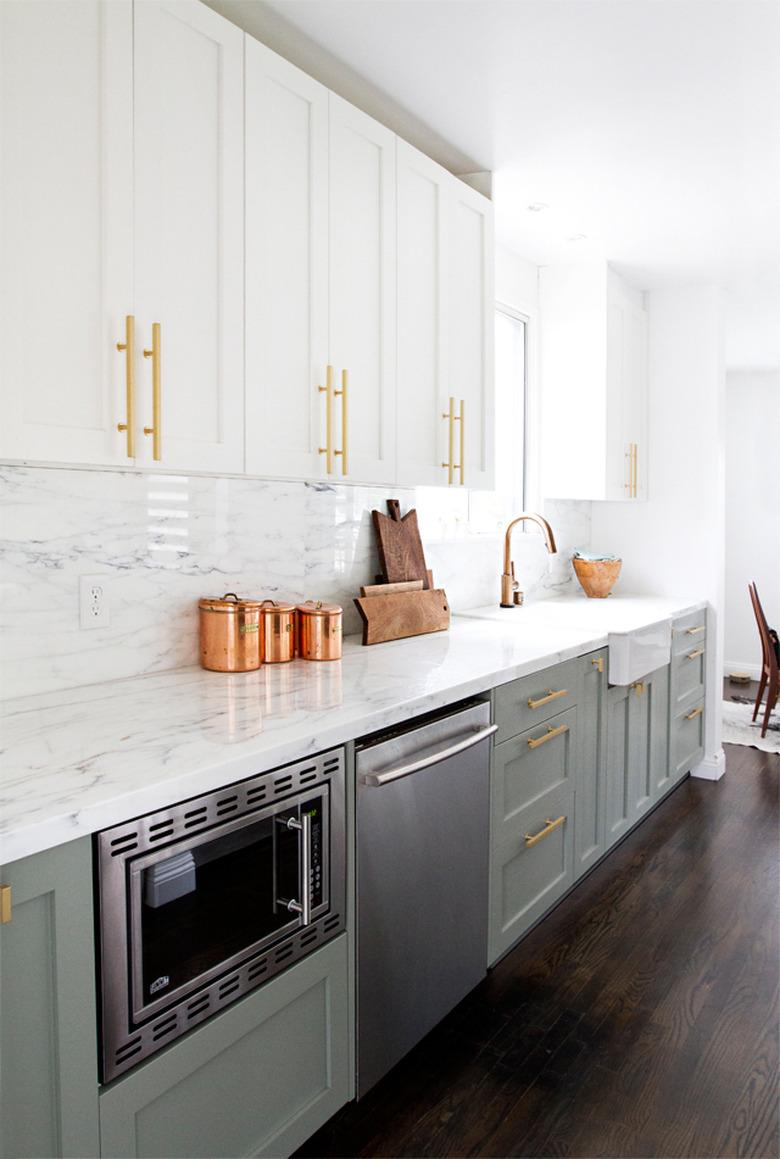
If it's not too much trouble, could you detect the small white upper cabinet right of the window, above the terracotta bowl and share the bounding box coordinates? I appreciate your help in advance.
[540,261,647,500]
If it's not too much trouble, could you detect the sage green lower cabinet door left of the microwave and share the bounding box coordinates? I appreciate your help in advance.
[0,837,100,1159]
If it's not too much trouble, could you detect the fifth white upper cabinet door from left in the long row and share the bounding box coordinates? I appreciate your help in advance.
[396,139,449,487]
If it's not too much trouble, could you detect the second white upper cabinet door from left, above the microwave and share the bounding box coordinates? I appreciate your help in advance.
[132,0,243,472]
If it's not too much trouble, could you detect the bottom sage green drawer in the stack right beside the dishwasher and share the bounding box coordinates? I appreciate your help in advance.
[490,786,574,962]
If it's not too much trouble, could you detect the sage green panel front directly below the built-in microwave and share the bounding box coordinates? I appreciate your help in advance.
[100,934,351,1159]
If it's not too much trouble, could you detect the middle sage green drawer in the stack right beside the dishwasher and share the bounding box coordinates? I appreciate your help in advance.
[493,708,577,841]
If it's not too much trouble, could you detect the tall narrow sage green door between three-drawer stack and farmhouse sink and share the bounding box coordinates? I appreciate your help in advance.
[574,648,608,877]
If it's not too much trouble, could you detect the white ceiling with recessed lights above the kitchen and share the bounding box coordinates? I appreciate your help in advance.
[210,0,780,364]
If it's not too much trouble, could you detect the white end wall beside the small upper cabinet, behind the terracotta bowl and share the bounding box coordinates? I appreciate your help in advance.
[591,286,726,777]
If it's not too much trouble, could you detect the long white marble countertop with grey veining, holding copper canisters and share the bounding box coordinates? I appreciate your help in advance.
[0,596,705,863]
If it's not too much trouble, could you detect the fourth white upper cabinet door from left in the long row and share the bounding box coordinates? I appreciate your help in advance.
[323,93,396,483]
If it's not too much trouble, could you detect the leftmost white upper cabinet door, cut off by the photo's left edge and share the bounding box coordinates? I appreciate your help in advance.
[0,0,132,464]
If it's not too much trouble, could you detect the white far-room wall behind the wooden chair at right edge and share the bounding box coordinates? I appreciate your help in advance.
[724,370,780,677]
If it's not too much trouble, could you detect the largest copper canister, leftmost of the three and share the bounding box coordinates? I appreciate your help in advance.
[198,591,263,672]
